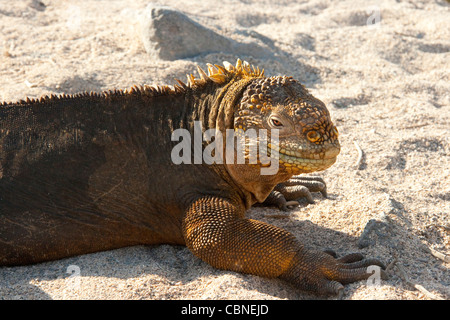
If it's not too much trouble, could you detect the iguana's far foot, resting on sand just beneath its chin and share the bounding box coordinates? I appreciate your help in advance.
[263,176,327,211]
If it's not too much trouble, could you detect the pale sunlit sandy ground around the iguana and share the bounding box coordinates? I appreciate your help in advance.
[0,0,450,299]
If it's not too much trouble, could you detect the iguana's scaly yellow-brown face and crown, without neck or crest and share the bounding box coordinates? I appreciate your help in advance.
[234,69,340,178]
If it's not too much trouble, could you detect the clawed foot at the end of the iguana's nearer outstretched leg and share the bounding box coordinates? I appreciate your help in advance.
[280,250,388,295]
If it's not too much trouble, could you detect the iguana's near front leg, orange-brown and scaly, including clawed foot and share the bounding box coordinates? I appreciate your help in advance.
[183,196,382,294]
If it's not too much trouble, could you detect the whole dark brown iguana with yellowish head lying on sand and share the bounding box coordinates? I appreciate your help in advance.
[0,59,383,294]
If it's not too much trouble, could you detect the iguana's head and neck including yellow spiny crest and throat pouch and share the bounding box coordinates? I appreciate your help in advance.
[188,59,340,201]
